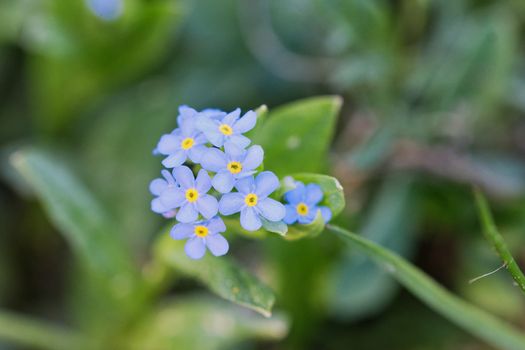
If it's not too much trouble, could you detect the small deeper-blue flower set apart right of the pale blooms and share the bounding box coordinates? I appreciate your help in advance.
[283,181,332,225]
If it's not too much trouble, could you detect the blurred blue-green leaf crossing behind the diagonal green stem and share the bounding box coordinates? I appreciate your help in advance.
[327,176,418,319]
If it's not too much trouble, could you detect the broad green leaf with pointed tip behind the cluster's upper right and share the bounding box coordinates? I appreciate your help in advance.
[253,96,342,176]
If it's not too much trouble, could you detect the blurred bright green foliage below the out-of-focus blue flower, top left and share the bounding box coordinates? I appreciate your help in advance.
[28,0,182,132]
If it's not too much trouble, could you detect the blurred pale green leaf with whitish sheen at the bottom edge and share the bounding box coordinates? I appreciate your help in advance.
[126,295,288,350]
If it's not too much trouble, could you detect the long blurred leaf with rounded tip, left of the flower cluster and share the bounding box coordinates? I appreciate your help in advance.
[11,148,140,328]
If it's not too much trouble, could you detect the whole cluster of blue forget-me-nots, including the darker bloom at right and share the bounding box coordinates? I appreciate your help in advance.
[150,106,331,259]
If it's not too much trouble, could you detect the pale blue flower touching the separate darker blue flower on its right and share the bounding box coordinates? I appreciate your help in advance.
[219,171,286,231]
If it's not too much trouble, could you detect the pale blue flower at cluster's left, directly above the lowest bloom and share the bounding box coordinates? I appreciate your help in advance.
[162,166,218,223]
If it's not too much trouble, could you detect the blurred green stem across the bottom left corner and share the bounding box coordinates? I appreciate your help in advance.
[0,311,94,350]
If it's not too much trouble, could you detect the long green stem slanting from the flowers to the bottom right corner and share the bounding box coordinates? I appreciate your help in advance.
[326,225,525,350]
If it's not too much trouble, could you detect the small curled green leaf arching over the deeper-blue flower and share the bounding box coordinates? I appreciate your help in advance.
[282,173,345,218]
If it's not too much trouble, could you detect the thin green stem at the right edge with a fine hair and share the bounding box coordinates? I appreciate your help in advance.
[474,189,525,293]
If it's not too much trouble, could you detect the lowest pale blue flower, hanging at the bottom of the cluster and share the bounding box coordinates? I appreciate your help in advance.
[171,216,229,259]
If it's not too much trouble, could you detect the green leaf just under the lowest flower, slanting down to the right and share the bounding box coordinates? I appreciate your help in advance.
[155,232,275,316]
